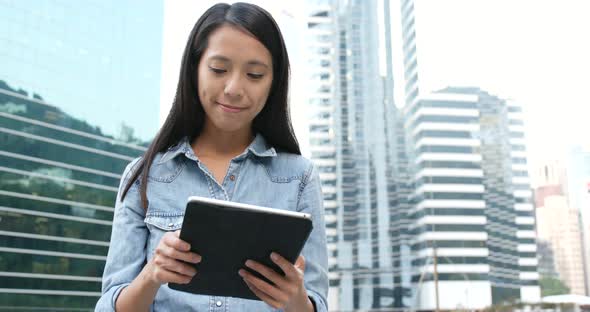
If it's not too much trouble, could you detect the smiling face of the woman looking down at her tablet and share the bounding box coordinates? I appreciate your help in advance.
[198,25,273,132]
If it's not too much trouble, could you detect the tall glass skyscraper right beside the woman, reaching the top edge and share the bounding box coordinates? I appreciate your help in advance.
[306,0,409,310]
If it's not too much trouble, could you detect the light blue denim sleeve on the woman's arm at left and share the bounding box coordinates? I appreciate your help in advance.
[95,159,148,312]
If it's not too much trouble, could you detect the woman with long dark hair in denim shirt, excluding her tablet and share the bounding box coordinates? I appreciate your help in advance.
[96,3,328,312]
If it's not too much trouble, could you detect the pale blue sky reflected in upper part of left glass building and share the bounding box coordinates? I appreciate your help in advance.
[0,0,164,141]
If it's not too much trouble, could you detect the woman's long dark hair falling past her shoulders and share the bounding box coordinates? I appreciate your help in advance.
[121,3,301,210]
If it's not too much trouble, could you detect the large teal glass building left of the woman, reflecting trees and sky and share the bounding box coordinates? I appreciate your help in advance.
[0,1,162,311]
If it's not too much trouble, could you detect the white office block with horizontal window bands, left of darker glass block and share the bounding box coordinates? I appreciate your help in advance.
[405,92,492,309]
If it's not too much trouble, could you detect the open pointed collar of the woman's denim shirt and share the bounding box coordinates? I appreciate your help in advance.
[158,133,277,164]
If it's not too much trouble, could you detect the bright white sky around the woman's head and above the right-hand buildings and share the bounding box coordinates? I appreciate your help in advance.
[161,0,590,171]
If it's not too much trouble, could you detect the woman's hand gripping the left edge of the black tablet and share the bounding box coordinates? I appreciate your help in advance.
[149,230,201,285]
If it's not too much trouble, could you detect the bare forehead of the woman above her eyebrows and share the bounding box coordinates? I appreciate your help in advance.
[203,24,272,66]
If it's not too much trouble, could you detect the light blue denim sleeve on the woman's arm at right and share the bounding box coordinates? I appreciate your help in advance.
[297,165,328,312]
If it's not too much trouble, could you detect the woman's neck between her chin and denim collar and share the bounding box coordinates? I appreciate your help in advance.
[192,125,253,157]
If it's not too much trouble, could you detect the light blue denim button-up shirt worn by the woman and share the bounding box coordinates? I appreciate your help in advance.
[96,134,328,312]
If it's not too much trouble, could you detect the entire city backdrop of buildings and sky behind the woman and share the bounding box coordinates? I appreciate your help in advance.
[0,0,590,311]
